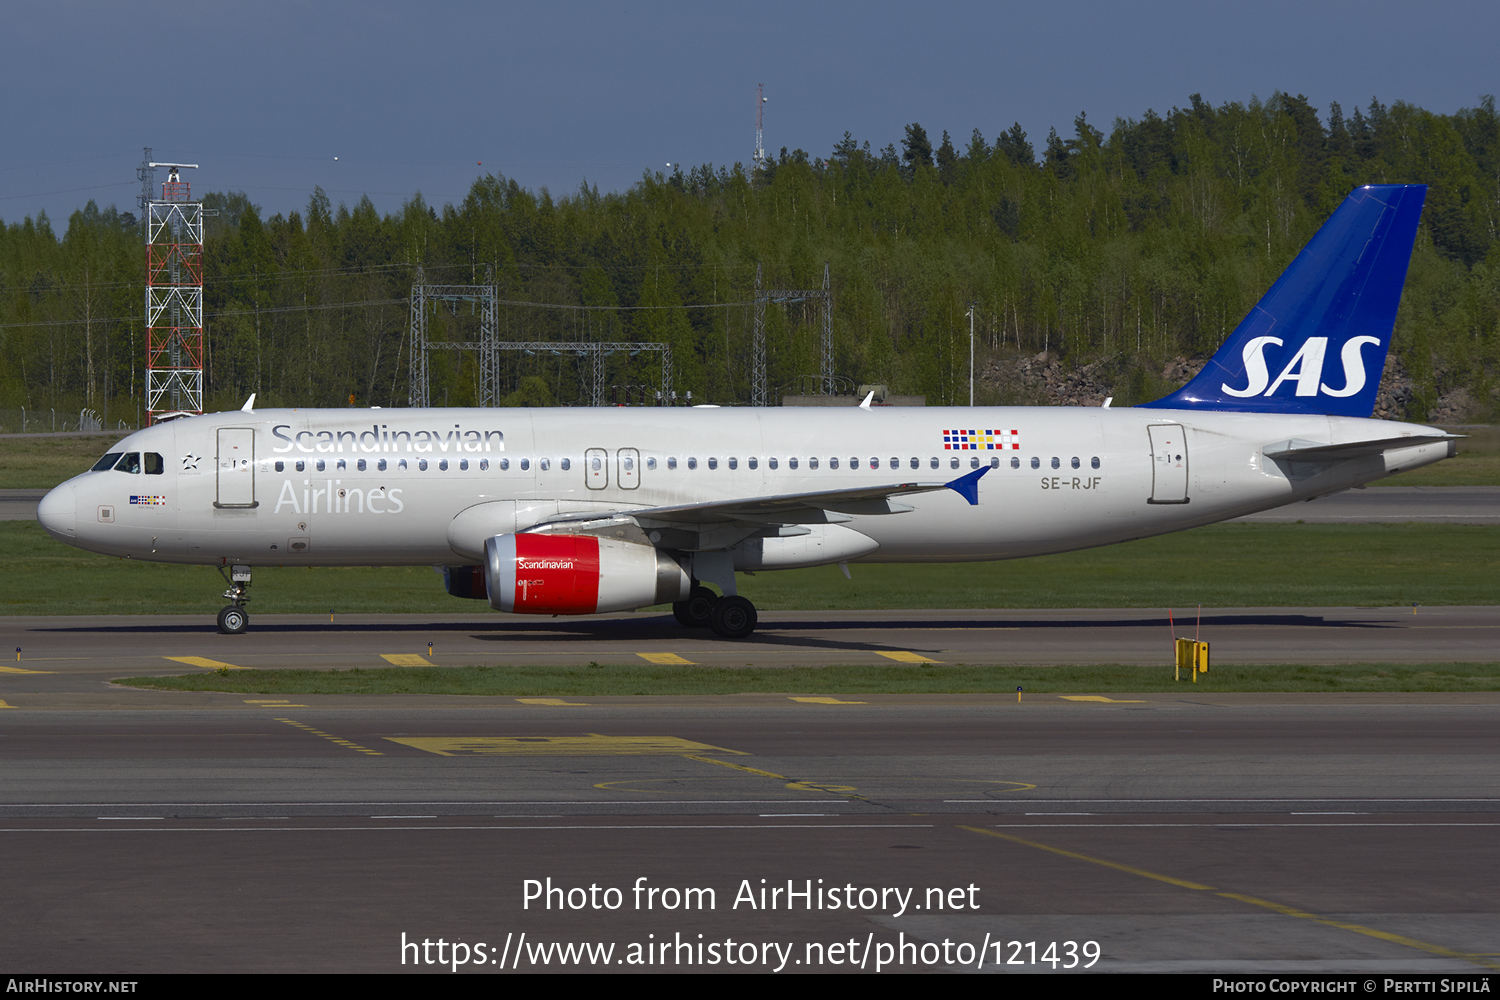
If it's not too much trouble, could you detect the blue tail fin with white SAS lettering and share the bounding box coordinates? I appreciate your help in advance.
[1145,184,1427,417]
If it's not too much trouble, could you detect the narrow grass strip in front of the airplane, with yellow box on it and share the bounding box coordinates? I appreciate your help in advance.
[116,663,1500,697]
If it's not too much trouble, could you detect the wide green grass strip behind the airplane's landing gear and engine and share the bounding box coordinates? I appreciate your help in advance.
[0,522,1500,614]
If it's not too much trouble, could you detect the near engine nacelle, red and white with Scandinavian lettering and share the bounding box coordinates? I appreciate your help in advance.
[485,532,692,615]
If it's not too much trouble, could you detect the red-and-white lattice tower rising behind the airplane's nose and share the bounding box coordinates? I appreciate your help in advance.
[137,147,203,424]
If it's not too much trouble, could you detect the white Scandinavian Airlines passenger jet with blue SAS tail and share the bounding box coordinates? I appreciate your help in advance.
[38,184,1458,639]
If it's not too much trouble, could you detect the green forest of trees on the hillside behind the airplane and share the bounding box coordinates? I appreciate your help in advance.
[0,93,1500,426]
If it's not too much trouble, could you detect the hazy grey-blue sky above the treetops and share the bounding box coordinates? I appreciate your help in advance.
[0,0,1500,231]
